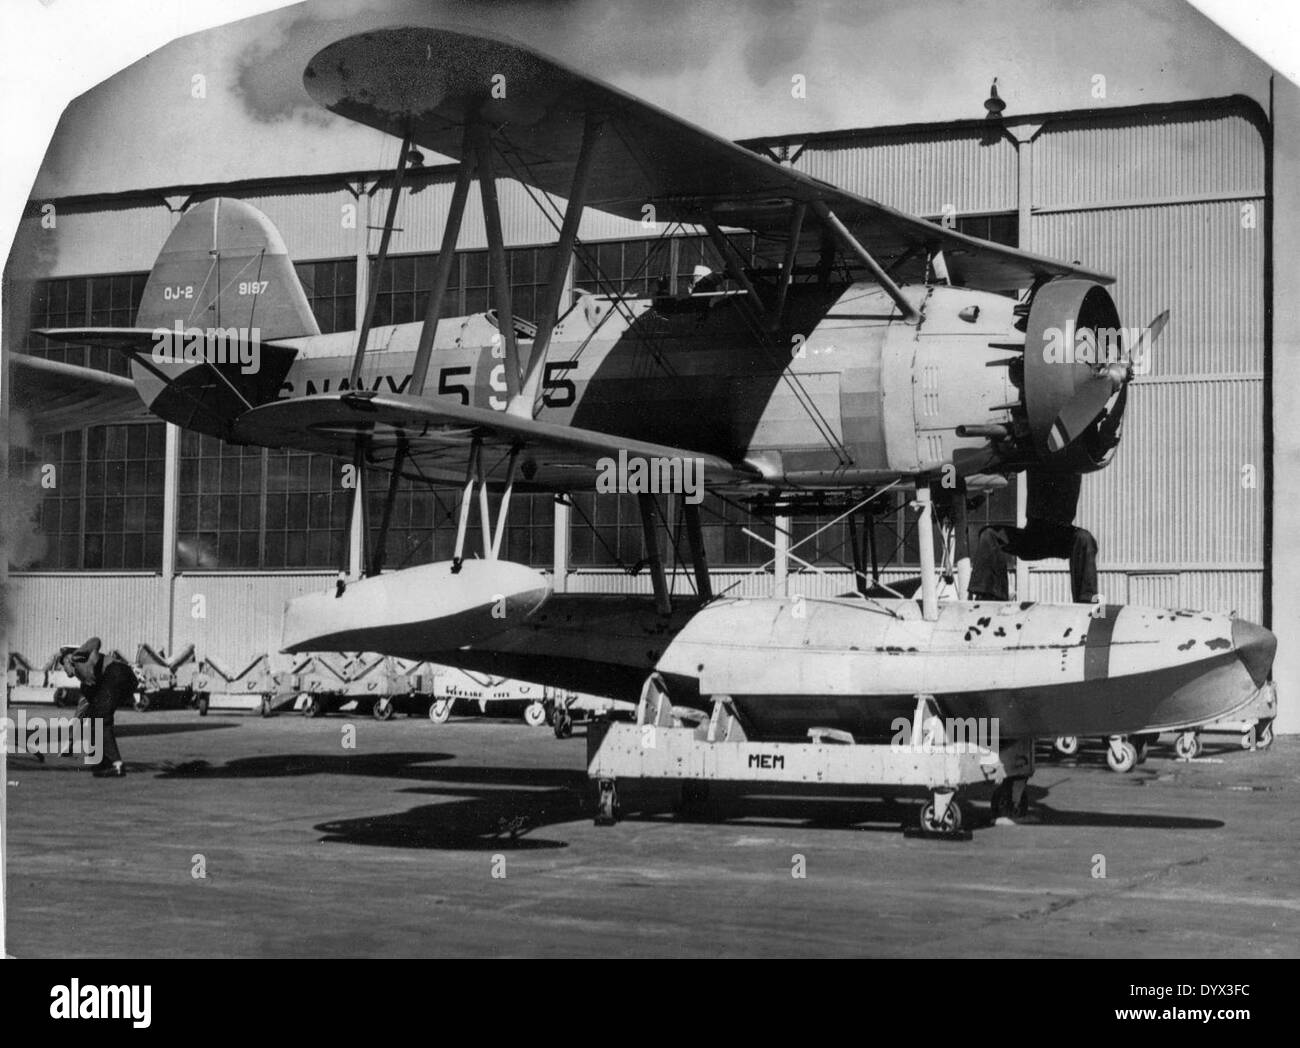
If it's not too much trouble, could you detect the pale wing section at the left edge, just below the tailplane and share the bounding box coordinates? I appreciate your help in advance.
[9,352,153,437]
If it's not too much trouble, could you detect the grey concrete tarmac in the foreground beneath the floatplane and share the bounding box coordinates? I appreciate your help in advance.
[8,707,1300,957]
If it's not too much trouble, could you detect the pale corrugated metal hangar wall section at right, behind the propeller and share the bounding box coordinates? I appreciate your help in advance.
[1028,108,1266,622]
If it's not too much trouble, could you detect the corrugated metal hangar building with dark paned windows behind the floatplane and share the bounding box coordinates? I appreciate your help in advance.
[9,96,1279,731]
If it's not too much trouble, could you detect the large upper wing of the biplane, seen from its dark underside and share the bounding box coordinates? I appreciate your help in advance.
[303,27,1113,290]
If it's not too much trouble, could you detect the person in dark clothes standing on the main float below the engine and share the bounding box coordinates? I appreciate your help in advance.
[970,473,1097,605]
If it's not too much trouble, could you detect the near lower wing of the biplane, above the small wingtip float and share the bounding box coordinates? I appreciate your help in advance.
[233,393,759,491]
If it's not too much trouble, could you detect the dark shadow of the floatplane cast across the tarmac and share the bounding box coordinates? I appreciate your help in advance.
[147,752,1223,850]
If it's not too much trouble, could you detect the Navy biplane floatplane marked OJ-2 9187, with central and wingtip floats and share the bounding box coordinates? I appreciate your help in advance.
[25,29,1275,826]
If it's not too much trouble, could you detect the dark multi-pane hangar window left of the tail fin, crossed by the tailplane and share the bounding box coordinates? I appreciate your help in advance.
[27,273,150,374]
